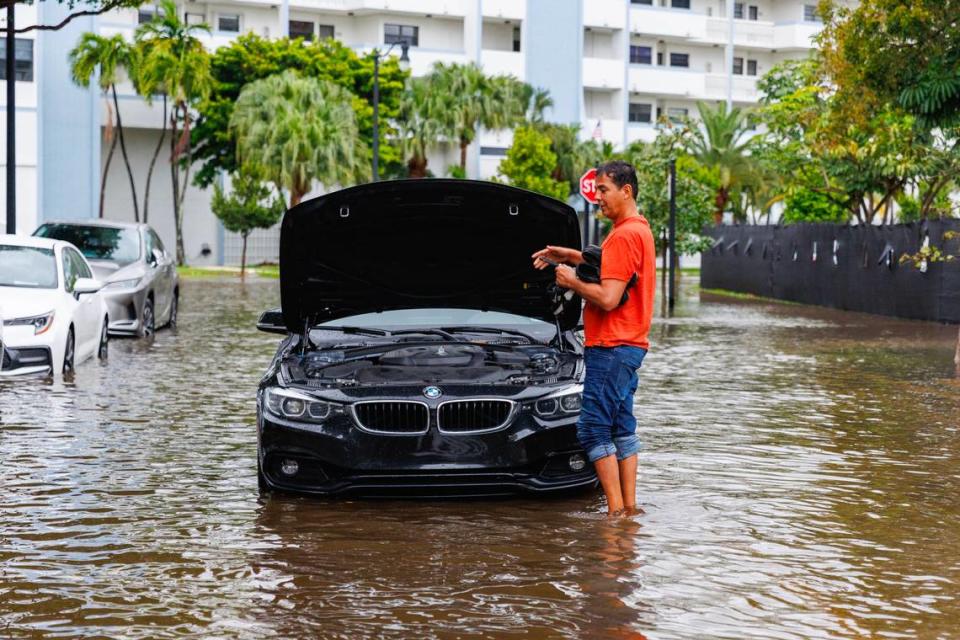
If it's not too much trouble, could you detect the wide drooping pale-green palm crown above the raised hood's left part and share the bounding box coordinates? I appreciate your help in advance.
[230,70,370,207]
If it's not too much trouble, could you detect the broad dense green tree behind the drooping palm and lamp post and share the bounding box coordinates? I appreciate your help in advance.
[192,34,409,186]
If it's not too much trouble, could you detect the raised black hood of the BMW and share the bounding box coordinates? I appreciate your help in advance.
[280,179,580,333]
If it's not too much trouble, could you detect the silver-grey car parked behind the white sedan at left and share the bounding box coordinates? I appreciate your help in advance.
[33,220,180,336]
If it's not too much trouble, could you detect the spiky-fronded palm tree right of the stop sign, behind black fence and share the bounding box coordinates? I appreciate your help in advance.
[688,102,752,224]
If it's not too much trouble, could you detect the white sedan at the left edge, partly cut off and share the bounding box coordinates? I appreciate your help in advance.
[0,235,109,376]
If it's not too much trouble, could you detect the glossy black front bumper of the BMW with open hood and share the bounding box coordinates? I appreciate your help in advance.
[257,412,597,497]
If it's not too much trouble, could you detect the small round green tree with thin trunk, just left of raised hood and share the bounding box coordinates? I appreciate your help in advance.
[210,166,284,277]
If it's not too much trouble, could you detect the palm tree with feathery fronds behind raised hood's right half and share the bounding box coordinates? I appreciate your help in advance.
[431,62,528,172]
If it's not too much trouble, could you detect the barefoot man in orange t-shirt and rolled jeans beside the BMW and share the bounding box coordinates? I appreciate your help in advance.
[533,161,656,515]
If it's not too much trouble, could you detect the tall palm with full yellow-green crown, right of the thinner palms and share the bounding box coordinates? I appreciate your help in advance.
[136,0,213,264]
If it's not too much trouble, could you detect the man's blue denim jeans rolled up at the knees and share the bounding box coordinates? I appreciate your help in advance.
[577,345,647,462]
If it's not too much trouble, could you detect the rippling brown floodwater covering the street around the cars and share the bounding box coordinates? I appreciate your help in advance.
[0,280,960,639]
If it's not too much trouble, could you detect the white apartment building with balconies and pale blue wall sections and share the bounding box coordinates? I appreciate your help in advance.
[0,0,820,265]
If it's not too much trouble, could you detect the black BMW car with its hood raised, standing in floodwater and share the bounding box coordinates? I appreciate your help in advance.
[257,180,596,496]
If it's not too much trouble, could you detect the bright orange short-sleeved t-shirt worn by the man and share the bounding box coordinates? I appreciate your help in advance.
[583,216,657,349]
